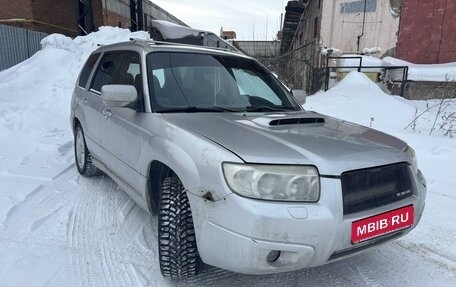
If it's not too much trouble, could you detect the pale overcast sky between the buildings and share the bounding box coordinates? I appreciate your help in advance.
[152,0,287,40]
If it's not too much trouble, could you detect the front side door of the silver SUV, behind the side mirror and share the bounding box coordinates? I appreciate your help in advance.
[100,51,147,201]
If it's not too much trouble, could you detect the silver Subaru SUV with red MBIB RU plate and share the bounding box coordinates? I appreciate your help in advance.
[71,40,426,279]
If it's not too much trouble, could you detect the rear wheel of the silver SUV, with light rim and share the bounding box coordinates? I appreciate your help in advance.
[74,125,101,176]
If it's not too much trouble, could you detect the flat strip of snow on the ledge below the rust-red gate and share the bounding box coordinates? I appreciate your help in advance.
[383,57,456,82]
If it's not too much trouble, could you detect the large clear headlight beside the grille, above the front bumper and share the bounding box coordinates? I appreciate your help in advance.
[223,163,320,202]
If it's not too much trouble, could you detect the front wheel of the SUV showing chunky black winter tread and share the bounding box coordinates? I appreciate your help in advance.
[158,177,201,279]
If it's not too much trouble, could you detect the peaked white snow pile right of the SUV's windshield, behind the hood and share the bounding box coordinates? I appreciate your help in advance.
[305,72,456,136]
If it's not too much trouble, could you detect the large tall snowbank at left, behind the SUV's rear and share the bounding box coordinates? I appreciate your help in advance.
[0,27,149,223]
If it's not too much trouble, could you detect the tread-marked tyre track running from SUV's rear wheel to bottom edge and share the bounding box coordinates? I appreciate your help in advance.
[70,176,129,286]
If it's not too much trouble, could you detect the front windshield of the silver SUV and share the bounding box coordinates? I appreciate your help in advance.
[147,52,300,112]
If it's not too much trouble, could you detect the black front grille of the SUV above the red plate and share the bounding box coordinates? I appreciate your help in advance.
[341,163,416,214]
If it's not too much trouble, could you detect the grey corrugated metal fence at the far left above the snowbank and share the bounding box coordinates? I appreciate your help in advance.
[0,25,48,71]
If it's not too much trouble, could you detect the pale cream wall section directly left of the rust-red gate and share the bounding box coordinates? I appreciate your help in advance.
[317,0,399,54]
